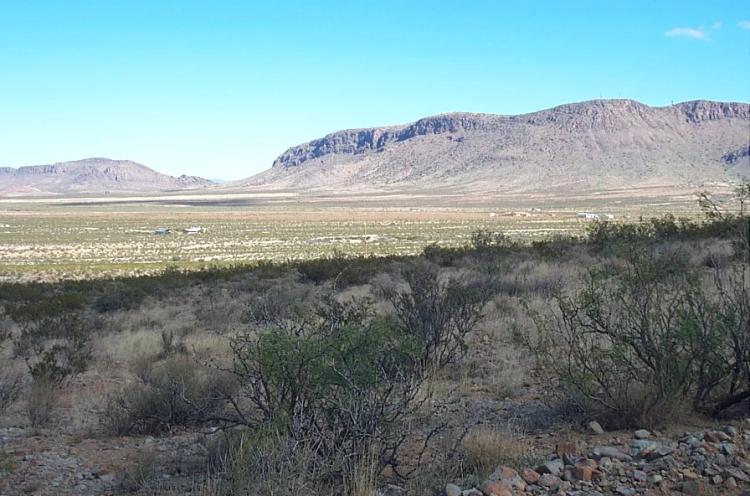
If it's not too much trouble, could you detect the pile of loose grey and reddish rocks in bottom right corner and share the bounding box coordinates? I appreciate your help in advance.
[445,422,750,496]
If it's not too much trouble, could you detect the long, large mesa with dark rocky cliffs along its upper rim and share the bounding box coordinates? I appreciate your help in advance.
[242,100,750,192]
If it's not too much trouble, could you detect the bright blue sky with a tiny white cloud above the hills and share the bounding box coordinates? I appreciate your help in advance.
[0,0,750,179]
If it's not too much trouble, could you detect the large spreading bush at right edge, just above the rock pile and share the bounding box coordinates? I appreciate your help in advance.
[519,202,750,427]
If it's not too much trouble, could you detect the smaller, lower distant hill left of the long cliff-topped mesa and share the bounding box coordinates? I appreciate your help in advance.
[0,158,213,196]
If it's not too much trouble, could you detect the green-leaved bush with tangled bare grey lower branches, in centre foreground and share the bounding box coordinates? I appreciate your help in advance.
[232,298,423,480]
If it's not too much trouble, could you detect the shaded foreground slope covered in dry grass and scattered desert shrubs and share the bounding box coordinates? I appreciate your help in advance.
[0,188,750,496]
